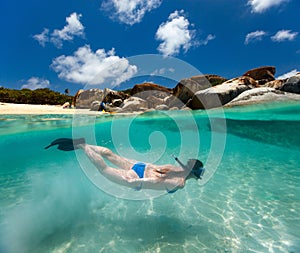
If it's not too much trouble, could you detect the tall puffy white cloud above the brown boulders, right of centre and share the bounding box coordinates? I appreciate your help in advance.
[156,10,194,56]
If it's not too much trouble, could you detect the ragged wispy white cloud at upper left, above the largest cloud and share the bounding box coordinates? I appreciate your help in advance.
[33,12,84,48]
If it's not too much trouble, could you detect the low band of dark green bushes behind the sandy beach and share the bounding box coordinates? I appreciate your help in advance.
[0,87,73,105]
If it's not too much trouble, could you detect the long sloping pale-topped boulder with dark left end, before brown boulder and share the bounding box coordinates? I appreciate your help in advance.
[187,76,257,109]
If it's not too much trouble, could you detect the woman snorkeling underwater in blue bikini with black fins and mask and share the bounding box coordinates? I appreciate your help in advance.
[46,138,205,193]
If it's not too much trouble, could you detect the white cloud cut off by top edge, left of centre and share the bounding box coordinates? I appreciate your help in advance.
[101,0,162,25]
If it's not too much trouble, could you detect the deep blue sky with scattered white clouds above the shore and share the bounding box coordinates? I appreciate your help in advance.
[0,0,300,94]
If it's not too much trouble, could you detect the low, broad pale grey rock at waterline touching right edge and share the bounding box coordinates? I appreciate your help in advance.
[225,87,300,106]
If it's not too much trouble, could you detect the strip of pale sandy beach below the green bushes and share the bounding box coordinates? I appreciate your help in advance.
[0,103,94,115]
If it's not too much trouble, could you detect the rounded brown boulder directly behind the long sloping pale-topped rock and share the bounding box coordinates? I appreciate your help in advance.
[173,75,226,104]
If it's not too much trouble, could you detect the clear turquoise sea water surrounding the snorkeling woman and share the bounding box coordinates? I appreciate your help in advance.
[0,103,300,253]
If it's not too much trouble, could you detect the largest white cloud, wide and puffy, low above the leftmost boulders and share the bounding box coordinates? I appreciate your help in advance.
[51,45,137,86]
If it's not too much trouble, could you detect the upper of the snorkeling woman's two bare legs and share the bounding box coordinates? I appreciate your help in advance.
[81,144,135,170]
